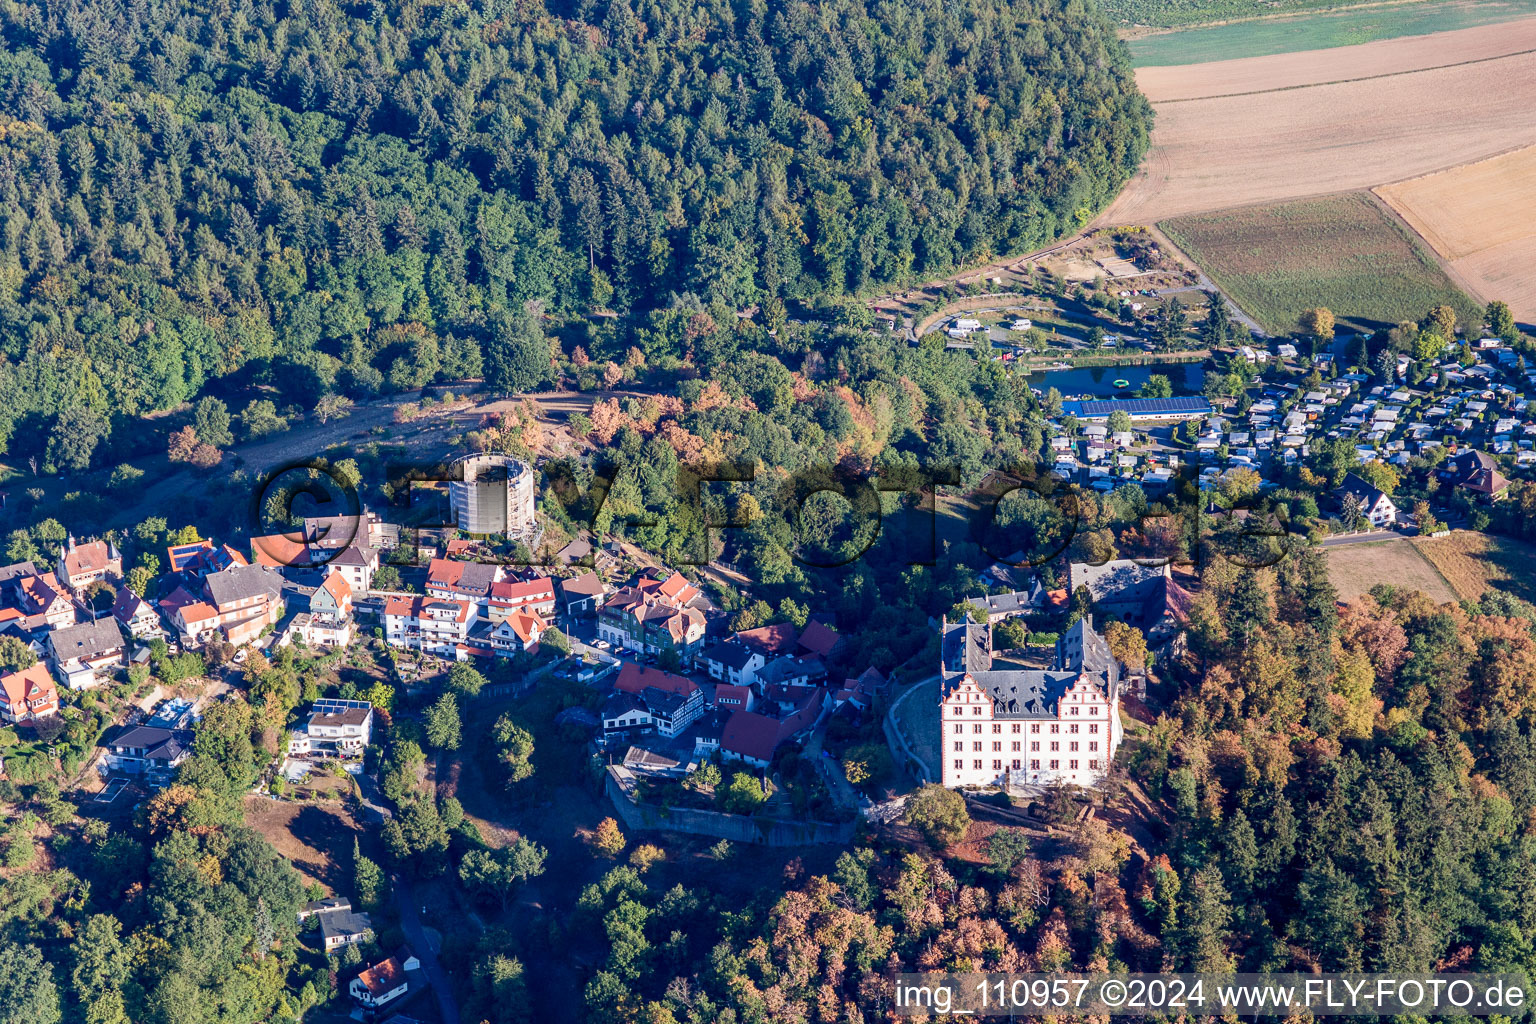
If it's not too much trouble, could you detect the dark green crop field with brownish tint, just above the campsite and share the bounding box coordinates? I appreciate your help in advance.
[1161,192,1482,332]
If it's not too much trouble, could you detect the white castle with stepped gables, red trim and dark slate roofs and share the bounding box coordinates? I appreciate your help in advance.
[938,616,1123,788]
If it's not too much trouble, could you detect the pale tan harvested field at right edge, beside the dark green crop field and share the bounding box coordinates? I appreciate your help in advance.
[1376,146,1536,321]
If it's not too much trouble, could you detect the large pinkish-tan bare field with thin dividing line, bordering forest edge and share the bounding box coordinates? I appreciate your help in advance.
[1097,18,1536,226]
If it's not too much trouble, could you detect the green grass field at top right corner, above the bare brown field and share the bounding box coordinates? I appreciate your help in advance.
[1107,0,1536,68]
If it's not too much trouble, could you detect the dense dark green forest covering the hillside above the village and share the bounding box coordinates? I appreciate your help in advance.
[0,0,1150,457]
